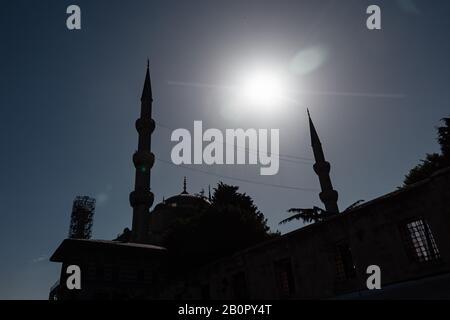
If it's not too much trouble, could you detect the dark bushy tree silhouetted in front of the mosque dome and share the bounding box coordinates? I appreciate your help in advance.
[160,182,277,271]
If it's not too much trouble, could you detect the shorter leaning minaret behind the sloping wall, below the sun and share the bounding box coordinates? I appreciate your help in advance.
[308,110,339,213]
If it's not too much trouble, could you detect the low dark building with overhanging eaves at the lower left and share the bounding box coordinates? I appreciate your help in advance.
[50,239,166,300]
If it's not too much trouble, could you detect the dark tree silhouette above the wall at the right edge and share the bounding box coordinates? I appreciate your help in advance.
[403,117,450,186]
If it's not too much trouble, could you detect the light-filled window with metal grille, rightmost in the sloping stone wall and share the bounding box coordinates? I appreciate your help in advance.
[402,219,440,262]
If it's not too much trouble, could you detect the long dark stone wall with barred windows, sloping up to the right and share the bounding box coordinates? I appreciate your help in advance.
[163,169,450,299]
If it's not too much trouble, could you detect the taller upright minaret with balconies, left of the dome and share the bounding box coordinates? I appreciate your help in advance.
[130,60,155,243]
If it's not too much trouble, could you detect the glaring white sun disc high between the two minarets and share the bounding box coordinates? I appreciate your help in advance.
[240,70,284,111]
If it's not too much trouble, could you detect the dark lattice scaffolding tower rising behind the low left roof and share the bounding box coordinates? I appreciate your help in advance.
[69,196,95,239]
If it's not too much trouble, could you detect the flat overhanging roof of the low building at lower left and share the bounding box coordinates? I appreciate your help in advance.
[50,239,167,262]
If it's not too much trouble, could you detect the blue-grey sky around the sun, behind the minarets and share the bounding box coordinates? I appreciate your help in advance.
[0,0,450,299]
